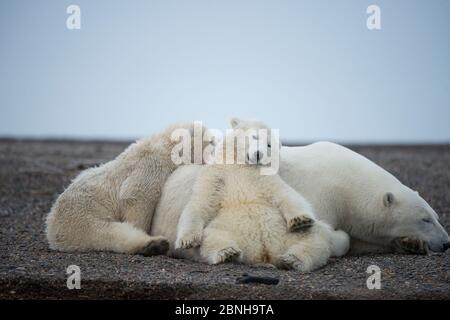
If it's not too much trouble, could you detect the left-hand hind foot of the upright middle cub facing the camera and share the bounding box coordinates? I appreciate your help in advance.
[200,228,242,264]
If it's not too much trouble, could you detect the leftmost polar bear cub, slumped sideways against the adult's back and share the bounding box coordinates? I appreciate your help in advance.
[46,122,205,255]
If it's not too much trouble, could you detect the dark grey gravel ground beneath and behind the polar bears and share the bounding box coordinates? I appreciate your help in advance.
[0,139,450,299]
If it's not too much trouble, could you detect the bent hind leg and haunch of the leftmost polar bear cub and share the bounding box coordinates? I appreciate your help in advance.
[47,194,169,255]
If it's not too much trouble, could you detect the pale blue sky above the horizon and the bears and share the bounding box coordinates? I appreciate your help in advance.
[0,0,450,142]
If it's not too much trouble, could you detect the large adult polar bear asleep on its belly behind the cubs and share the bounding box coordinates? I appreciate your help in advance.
[151,142,450,258]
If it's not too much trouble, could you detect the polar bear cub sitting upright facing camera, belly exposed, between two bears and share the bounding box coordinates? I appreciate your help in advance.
[175,119,349,272]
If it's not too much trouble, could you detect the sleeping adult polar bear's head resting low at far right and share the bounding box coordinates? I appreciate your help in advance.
[378,186,450,253]
